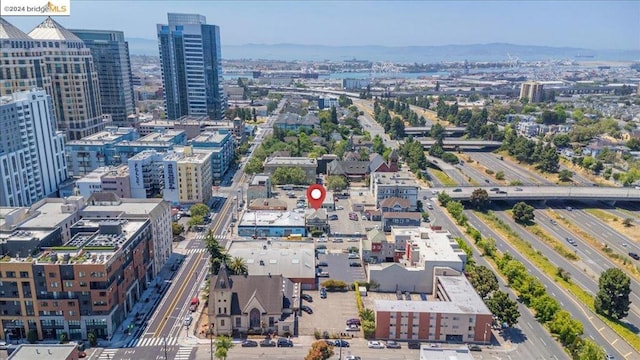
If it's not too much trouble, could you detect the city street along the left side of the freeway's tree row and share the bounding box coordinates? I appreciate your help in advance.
[420,198,569,360]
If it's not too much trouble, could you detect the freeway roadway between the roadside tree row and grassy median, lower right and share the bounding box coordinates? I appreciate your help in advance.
[465,210,637,359]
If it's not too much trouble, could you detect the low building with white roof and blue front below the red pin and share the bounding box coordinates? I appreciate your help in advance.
[238,211,307,237]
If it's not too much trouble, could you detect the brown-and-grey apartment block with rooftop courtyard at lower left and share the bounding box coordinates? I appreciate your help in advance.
[0,193,172,340]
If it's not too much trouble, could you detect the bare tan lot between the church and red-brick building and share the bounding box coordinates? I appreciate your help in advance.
[299,286,362,337]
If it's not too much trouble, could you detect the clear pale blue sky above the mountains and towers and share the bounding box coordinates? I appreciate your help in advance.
[5,0,640,50]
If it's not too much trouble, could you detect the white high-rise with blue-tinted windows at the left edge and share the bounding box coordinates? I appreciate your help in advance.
[0,89,67,206]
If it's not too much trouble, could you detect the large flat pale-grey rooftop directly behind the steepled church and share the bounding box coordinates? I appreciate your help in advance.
[229,240,315,278]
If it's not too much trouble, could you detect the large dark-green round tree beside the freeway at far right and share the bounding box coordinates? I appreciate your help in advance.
[594,268,631,319]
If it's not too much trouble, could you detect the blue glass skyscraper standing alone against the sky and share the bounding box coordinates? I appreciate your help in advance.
[157,13,226,120]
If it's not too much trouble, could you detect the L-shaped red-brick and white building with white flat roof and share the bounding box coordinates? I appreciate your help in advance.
[373,275,493,343]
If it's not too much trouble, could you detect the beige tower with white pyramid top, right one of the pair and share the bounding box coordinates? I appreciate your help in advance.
[29,17,108,140]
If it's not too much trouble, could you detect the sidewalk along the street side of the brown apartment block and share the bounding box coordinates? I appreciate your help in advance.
[104,253,184,348]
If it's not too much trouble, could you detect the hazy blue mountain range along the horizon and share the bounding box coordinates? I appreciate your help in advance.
[127,38,640,64]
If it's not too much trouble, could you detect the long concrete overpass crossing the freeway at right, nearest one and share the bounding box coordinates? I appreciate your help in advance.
[431,186,640,202]
